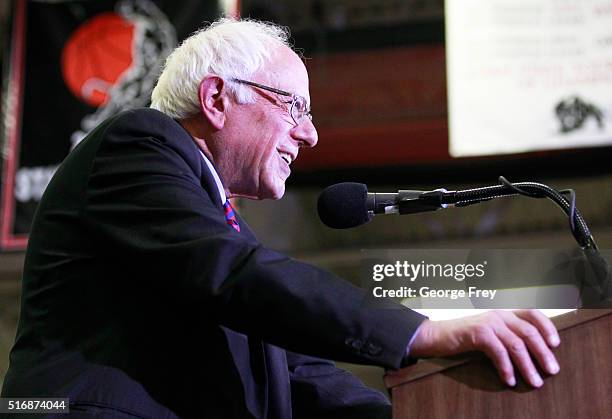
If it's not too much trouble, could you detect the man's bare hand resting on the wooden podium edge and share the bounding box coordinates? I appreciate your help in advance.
[410,310,560,387]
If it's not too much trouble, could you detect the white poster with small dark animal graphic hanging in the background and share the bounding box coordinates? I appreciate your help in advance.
[446,0,612,157]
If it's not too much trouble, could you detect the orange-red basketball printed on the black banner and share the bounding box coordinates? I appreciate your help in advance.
[61,12,134,107]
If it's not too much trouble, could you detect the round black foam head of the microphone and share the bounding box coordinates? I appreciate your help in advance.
[317,182,372,228]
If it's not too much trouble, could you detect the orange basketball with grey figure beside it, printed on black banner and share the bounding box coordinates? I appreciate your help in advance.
[61,0,176,147]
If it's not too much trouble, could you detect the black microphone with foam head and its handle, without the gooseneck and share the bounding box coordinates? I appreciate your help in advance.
[317,182,452,229]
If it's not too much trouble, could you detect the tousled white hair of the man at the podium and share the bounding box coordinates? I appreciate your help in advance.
[151,18,291,119]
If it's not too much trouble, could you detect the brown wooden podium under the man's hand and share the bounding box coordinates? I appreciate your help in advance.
[385,309,612,419]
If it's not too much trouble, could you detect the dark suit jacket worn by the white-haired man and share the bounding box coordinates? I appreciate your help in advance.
[3,109,423,419]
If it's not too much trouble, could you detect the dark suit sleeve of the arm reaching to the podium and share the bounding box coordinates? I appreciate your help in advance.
[81,114,423,368]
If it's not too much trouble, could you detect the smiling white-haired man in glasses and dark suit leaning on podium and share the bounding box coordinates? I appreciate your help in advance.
[3,20,559,419]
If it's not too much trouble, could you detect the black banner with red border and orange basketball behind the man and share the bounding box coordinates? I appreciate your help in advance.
[0,0,220,249]
